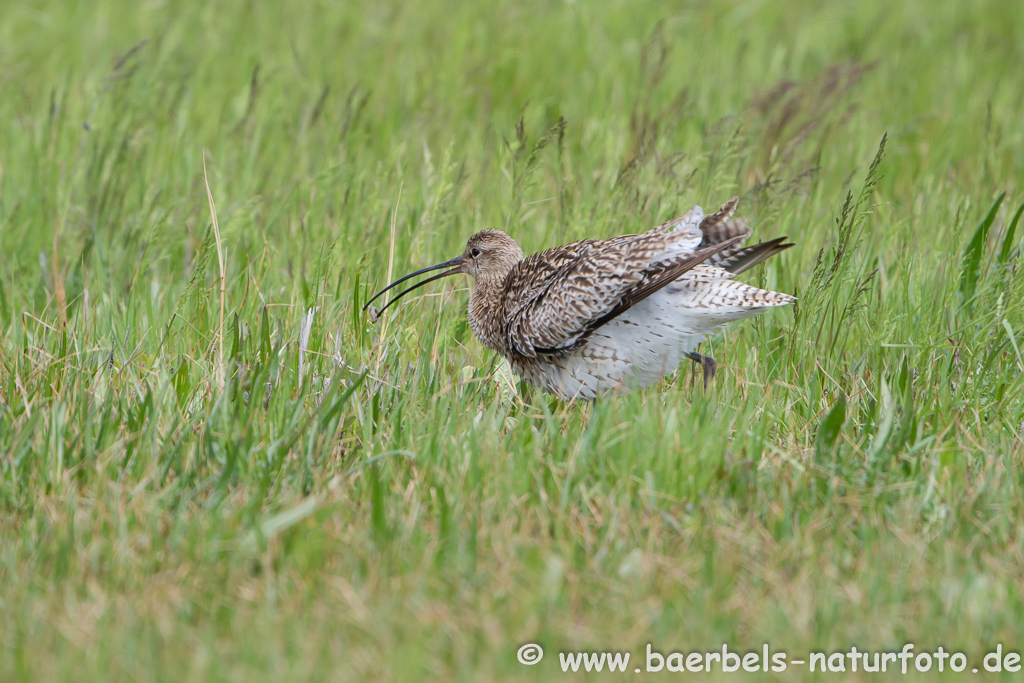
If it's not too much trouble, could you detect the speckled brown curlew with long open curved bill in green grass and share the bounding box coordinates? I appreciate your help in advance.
[364,197,796,400]
